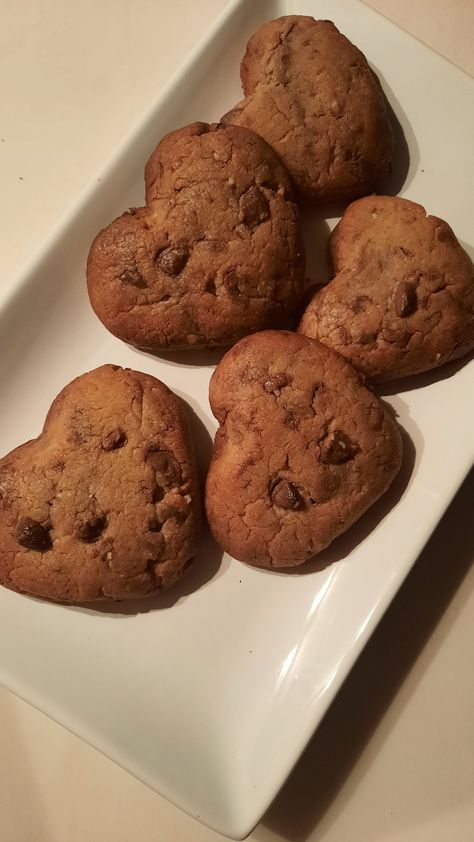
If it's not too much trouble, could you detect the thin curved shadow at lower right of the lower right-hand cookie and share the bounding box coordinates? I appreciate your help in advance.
[264,424,416,576]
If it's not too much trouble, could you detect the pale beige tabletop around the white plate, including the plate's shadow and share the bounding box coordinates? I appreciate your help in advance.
[0,0,474,842]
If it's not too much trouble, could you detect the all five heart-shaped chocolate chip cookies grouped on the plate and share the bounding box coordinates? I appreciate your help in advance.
[0,15,474,602]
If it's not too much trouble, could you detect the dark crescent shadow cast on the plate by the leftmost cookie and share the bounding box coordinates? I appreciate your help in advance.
[75,392,224,617]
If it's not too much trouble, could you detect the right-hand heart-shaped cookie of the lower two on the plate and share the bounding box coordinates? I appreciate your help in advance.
[206,331,402,567]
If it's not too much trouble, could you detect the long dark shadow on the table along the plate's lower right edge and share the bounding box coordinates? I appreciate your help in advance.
[262,471,474,842]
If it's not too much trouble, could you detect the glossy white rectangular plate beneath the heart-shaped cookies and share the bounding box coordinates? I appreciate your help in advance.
[0,0,474,838]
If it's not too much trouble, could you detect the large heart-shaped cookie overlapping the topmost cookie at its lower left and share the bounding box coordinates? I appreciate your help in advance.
[87,123,304,351]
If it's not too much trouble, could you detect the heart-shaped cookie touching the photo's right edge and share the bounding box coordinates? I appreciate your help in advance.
[298,196,474,382]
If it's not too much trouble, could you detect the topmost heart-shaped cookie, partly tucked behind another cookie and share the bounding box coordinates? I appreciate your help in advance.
[222,15,393,200]
